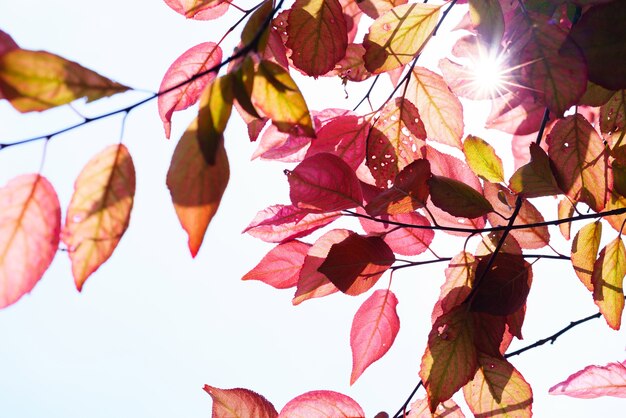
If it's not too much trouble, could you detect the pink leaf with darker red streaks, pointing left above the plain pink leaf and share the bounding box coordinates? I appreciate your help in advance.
[243,205,341,242]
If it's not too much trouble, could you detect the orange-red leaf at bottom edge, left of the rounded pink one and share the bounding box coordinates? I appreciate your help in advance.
[204,385,278,418]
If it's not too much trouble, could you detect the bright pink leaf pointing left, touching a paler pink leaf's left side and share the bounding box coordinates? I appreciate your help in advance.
[241,240,311,289]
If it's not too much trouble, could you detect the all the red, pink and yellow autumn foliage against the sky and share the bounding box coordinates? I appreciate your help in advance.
[0,0,626,417]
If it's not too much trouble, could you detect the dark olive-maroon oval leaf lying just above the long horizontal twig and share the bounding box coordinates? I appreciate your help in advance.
[428,176,493,218]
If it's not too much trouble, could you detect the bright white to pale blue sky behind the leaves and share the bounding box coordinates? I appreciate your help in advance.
[0,0,626,418]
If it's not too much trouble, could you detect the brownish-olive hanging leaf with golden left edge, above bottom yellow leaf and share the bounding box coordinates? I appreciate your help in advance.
[419,306,478,412]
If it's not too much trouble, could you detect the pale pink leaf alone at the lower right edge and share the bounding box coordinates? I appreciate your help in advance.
[549,361,626,399]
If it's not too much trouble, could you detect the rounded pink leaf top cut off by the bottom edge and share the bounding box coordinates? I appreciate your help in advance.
[279,390,365,418]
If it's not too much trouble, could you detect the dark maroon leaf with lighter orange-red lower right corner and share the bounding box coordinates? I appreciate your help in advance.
[318,232,395,296]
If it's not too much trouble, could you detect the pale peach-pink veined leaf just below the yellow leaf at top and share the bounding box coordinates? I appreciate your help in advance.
[406,66,464,149]
